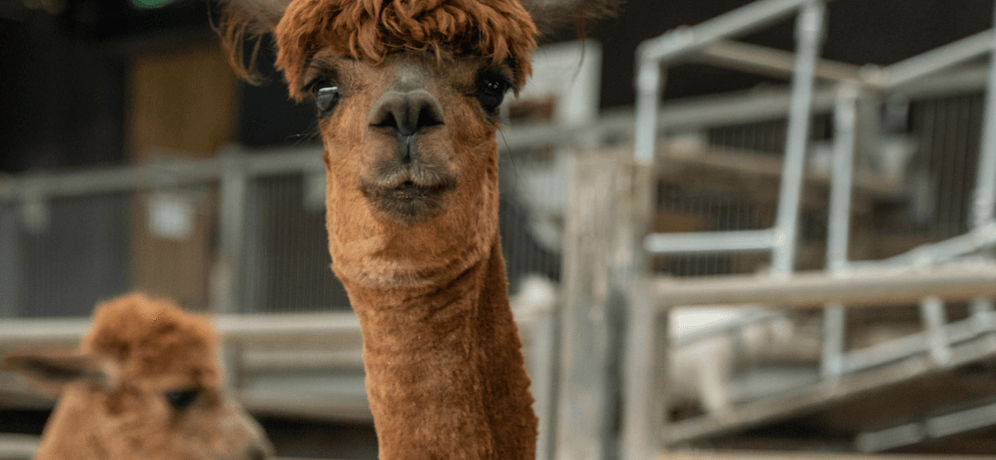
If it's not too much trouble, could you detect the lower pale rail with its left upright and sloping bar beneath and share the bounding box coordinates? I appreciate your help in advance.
[622,263,996,459]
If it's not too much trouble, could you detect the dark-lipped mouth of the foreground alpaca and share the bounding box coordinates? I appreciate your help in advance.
[361,178,456,225]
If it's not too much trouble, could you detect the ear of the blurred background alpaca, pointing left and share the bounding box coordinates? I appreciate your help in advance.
[0,351,117,395]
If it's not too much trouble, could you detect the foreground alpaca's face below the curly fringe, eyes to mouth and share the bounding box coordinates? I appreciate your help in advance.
[304,52,511,227]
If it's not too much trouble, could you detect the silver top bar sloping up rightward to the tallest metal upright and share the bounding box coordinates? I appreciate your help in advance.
[637,0,809,62]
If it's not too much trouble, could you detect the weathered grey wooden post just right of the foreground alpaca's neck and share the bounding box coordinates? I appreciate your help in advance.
[556,151,650,460]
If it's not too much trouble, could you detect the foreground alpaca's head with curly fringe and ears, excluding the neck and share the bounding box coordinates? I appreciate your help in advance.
[215,0,612,287]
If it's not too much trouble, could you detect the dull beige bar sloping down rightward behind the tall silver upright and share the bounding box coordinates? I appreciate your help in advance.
[694,40,867,83]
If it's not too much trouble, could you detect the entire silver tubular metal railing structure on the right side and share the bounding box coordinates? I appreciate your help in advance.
[616,0,996,459]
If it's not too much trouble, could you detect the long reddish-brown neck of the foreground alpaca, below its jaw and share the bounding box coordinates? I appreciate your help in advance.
[344,237,537,460]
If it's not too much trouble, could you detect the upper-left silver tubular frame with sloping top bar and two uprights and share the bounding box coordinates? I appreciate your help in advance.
[634,0,825,273]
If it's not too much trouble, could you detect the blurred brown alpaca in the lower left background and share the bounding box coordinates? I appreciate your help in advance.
[3,294,272,460]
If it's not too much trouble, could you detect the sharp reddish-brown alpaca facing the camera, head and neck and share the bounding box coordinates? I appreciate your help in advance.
[213,0,601,459]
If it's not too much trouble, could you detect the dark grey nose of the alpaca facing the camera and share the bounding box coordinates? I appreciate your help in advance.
[369,89,443,138]
